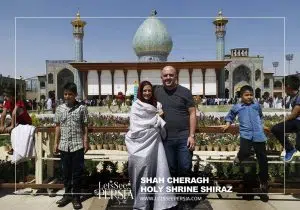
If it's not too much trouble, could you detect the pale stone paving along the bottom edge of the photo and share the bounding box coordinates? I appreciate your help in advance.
[0,190,300,210]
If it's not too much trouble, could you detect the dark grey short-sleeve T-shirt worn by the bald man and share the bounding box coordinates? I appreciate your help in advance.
[154,85,195,139]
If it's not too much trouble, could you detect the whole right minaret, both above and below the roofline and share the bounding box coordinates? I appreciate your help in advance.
[213,10,228,98]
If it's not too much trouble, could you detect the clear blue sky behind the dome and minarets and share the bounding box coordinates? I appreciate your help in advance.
[0,0,300,78]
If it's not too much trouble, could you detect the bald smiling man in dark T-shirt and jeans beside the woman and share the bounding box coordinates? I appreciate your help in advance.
[154,66,196,176]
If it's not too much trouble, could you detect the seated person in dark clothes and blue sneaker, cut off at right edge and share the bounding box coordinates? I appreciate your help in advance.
[272,75,300,162]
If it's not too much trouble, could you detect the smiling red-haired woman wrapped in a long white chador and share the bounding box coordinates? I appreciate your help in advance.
[125,81,177,210]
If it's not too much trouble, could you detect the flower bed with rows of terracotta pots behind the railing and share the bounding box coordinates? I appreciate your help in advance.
[28,113,288,152]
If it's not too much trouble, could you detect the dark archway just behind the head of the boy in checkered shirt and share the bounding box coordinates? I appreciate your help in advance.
[57,69,74,99]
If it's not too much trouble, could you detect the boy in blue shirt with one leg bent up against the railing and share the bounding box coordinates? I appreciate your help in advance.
[223,85,268,200]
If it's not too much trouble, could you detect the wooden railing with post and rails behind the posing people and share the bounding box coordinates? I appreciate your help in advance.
[0,126,299,192]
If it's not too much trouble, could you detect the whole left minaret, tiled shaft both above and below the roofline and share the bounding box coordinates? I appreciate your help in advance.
[71,10,87,100]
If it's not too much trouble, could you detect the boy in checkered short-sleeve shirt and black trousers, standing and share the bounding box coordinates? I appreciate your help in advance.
[54,83,89,209]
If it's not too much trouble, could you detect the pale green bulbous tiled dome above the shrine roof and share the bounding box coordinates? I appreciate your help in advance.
[133,11,173,61]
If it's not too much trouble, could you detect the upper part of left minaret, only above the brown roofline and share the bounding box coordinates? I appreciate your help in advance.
[71,10,86,62]
